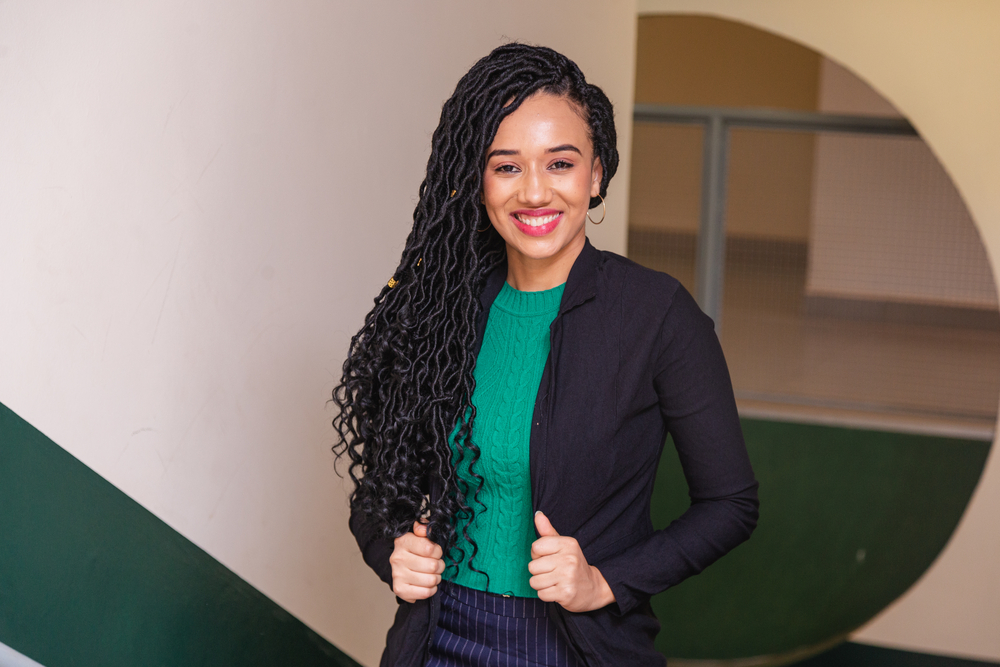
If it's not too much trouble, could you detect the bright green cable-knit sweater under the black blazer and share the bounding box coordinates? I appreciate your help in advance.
[451,283,565,597]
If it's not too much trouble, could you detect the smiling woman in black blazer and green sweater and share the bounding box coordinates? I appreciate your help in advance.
[334,44,757,666]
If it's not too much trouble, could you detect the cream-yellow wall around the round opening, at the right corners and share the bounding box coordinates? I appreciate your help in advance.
[638,0,1000,660]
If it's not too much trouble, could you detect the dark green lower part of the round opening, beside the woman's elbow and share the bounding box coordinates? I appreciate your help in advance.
[653,419,990,664]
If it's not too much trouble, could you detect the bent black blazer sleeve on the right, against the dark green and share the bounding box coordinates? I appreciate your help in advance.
[596,287,758,614]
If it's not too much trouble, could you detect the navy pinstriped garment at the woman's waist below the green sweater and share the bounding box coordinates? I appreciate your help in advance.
[426,581,584,667]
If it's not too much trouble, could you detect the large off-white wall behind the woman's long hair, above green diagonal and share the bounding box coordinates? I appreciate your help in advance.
[0,0,635,664]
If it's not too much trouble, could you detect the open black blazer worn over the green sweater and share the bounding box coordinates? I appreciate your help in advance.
[350,241,758,667]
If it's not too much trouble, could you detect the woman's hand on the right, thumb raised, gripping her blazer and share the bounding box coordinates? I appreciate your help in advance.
[528,512,615,612]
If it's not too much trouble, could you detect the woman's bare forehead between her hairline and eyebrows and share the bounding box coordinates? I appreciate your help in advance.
[490,92,591,151]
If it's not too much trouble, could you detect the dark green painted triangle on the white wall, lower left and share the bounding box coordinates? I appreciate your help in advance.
[0,404,358,667]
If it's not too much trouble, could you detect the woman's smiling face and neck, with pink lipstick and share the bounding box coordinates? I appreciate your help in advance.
[483,92,603,291]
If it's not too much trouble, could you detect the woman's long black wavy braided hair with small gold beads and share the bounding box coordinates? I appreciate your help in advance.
[333,43,618,571]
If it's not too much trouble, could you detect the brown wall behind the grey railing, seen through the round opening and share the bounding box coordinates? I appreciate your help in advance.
[631,16,820,241]
